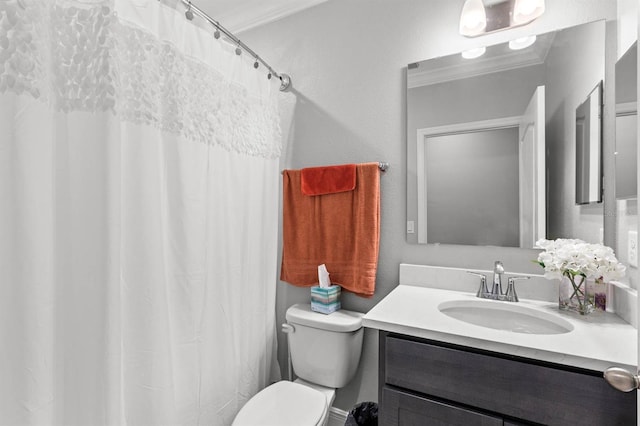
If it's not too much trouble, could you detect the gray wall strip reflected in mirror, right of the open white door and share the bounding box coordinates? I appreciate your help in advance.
[545,19,605,243]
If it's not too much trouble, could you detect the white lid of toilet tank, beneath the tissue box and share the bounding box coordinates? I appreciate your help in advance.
[286,303,364,333]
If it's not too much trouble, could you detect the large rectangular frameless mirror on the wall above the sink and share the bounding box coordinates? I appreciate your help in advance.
[407,21,605,248]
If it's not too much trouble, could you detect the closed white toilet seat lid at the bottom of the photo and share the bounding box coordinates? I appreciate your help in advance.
[233,380,328,426]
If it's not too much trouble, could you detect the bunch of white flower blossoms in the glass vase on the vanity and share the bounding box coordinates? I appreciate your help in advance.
[536,238,626,282]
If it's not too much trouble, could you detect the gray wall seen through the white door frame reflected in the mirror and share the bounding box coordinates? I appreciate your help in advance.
[424,127,520,247]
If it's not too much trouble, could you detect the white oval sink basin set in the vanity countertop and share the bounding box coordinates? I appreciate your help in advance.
[438,299,573,334]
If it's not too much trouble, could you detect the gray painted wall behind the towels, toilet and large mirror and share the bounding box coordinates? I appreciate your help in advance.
[241,0,616,409]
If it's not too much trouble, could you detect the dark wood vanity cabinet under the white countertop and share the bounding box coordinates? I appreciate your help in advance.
[379,331,637,426]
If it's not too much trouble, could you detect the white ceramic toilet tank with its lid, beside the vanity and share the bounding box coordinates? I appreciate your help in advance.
[286,304,364,388]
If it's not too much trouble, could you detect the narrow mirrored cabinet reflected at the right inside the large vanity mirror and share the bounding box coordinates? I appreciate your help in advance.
[576,83,602,204]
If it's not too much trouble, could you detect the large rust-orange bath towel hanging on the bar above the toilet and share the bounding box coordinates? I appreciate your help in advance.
[280,163,380,297]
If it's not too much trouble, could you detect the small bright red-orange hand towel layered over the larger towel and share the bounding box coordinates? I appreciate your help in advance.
[300,164,356,195]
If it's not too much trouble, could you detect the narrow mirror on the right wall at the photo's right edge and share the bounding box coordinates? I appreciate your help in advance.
[616,42,638,199]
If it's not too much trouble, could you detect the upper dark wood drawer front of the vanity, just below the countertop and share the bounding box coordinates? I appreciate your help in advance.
[380,335,637,426]
